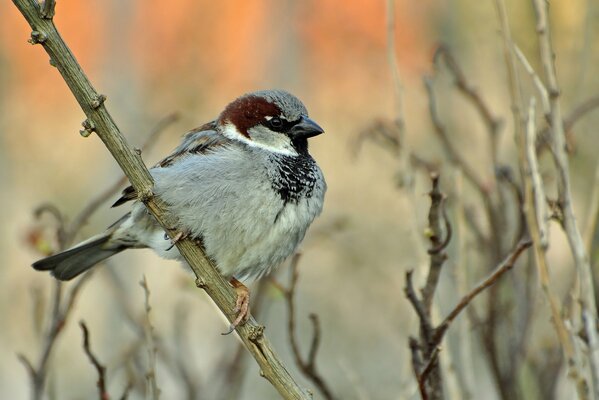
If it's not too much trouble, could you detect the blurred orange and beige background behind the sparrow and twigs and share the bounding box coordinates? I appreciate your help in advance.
[0,0,599,400]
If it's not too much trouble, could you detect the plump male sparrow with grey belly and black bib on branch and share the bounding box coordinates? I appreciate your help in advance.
[32,89,327,333]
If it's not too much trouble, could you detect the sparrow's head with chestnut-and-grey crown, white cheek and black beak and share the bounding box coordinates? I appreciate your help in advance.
[217,90,324,155]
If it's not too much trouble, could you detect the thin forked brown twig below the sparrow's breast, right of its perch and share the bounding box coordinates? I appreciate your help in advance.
[271,253,335,400]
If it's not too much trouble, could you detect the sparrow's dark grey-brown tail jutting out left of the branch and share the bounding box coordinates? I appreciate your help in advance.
[32,232,127,281]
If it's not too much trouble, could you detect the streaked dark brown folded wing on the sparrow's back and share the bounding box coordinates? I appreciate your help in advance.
[112,121,231,207]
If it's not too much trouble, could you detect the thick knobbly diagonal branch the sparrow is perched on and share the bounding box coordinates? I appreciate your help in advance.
[13,0,311,399]
